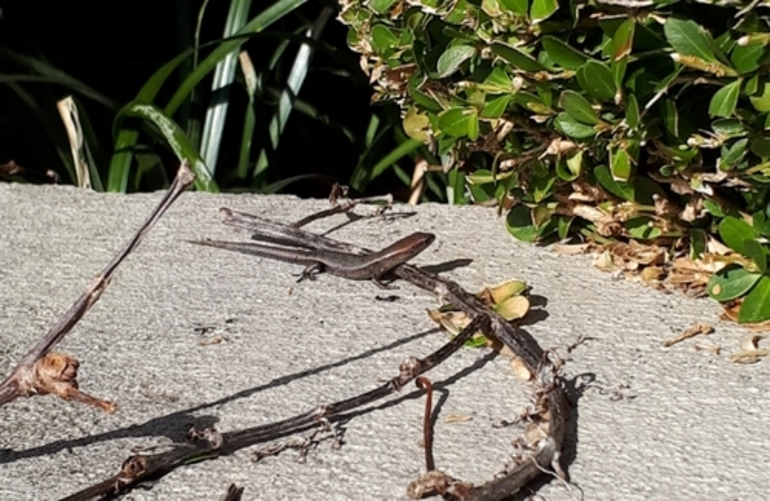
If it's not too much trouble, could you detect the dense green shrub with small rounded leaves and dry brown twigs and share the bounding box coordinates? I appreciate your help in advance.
[340,0,770,322]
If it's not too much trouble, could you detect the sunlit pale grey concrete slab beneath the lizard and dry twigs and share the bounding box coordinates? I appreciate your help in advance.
[0,184,770,500]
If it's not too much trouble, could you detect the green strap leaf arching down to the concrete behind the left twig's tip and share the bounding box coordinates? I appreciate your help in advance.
[119,101,219,192]
